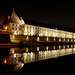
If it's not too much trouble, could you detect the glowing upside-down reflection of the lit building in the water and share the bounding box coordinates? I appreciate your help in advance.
[3,45,75,72]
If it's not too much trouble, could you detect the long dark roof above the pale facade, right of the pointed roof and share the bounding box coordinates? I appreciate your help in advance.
[24,19,75,32]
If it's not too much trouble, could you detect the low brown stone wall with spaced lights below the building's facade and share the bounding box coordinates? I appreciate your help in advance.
[10,35,75,42]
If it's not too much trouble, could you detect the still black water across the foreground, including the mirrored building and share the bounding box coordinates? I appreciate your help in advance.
[0,45,75,75]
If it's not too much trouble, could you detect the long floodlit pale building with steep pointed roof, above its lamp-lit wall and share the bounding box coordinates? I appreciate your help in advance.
[3,10,75,42]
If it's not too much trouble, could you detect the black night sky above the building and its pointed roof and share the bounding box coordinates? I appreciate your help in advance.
[0,0,75,29]
